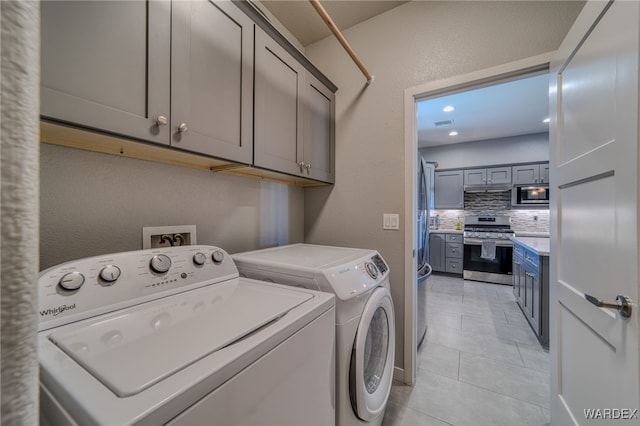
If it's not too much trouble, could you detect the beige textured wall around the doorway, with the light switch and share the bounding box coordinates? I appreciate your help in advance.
[305,1,583,372]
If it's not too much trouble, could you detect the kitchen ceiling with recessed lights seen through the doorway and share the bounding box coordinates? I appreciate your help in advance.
[416,73,549,148]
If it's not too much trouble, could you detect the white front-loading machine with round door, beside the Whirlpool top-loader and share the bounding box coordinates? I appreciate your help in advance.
[232,244,395,425]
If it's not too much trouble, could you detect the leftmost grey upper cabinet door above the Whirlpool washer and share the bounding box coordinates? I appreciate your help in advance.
[40,1,171,144]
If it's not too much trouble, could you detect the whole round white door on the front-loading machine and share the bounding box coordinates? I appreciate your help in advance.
[349,287,395,421]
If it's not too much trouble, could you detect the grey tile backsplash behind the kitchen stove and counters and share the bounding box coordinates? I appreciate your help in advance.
[431,191,549,233]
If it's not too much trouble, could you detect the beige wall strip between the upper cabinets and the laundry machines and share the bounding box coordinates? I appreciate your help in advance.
[40,144,304,269]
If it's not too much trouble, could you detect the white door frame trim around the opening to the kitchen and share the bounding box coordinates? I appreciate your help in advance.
[402,51,555,385]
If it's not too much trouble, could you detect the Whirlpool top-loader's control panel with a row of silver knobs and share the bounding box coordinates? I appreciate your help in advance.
[38,245,238,330]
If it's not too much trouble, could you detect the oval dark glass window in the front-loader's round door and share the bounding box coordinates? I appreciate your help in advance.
[363,307,389,393]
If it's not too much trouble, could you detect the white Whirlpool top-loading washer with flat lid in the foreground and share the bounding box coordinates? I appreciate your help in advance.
[38,246,335,426]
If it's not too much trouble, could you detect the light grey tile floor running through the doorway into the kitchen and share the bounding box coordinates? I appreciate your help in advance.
[382,274,549,426]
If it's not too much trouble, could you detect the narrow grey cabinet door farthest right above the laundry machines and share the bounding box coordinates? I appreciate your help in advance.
[304,73,335,183]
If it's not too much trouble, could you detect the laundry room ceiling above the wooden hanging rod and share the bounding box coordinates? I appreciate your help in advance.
[260,0,407,46]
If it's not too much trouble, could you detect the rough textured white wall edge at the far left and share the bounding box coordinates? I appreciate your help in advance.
[0,1,40,425]
